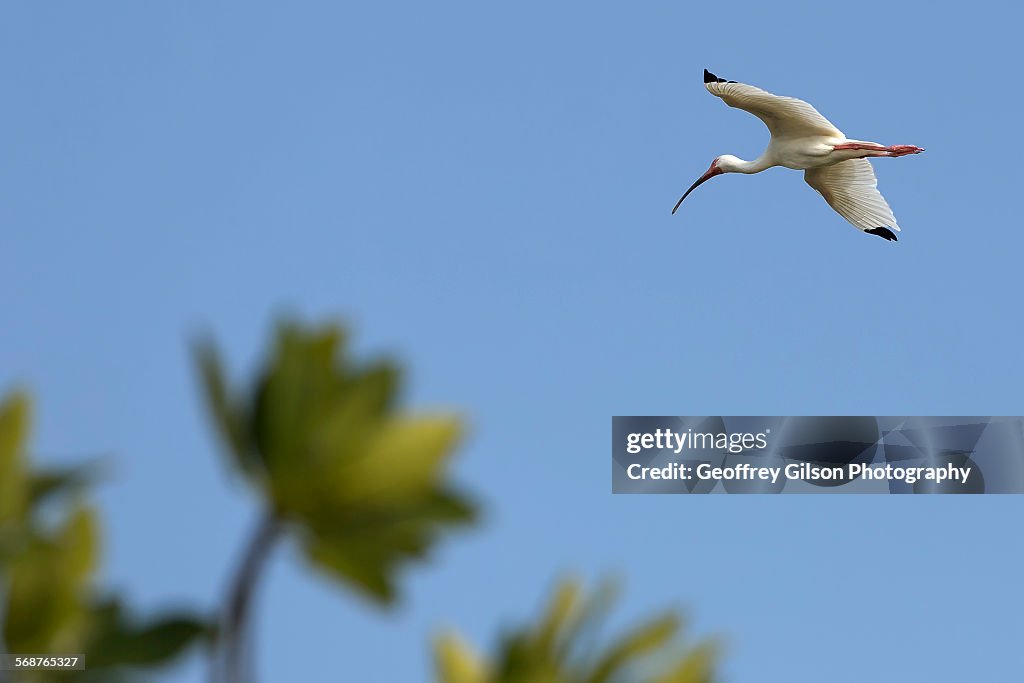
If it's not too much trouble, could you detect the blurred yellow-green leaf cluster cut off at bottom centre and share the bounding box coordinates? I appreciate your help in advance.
[434,582,717,683]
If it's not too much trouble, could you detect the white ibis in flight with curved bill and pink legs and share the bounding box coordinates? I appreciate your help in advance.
[672,69,924,242]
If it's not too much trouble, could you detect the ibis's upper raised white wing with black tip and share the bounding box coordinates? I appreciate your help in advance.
[705,69,846,137]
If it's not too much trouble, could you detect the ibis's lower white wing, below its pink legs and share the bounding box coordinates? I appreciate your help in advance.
[804,159,899,240]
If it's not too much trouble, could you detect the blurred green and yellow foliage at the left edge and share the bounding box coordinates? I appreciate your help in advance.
[0,393,209,683]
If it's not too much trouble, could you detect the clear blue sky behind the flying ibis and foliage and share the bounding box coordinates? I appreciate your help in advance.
[0,0,1024,683]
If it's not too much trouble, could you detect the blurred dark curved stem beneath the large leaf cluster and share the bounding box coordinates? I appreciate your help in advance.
[213,512,281,683]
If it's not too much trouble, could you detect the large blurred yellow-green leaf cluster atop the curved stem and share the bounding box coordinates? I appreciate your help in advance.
[197,324,474,602]
